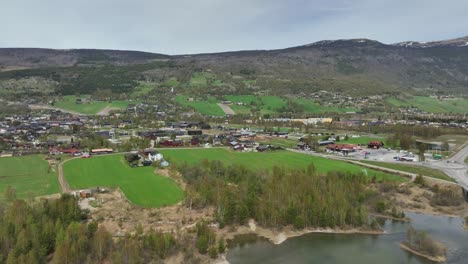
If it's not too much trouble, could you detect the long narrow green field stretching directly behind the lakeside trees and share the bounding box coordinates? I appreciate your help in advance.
[161,148,405,181]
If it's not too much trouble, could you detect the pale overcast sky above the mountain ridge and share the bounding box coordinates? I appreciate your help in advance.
[0,0,468,54]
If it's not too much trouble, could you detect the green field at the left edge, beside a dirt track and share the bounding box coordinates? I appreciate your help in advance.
[0,155,60,200]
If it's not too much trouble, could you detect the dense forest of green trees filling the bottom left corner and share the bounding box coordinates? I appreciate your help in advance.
[0,194,178,264]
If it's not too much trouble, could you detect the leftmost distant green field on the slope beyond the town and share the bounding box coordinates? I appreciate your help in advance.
[54,95,136,115]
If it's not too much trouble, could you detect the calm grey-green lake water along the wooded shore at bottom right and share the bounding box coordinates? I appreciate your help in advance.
[227,213,468,264]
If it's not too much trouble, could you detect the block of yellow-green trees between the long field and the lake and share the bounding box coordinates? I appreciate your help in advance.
[178,160,376,228]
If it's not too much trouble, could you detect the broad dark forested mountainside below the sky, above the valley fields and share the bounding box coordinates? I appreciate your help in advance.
[0,36,468,99]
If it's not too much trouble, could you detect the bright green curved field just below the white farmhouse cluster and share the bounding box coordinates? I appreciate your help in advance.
[63,155,184,207]
